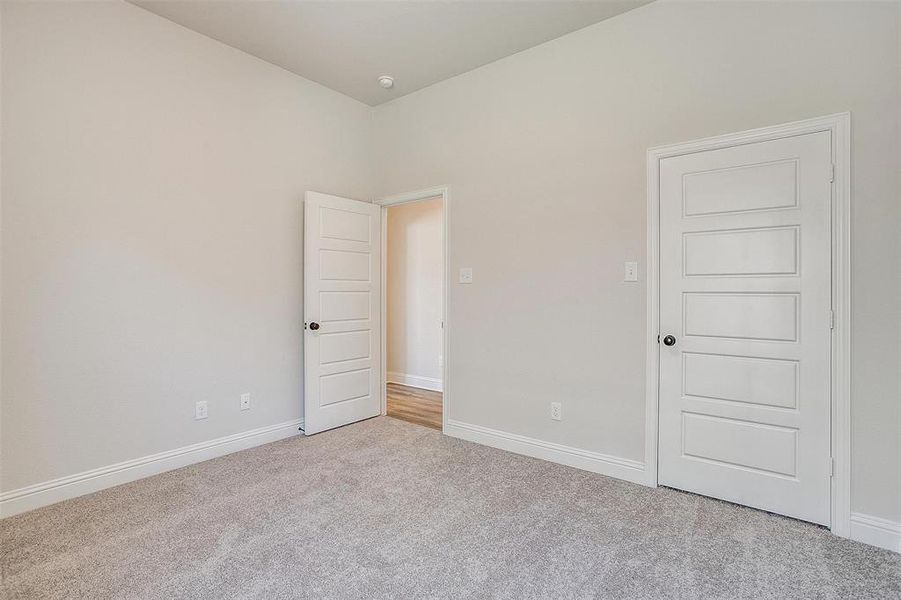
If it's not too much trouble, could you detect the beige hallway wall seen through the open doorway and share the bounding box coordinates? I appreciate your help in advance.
[387,198,444,385]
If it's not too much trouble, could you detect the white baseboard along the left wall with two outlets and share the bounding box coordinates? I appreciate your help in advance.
[0,419,303,518]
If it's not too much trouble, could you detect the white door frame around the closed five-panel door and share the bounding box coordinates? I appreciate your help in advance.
[645,112,851,537]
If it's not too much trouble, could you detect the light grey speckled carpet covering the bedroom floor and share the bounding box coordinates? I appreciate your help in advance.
[0,417,901,600]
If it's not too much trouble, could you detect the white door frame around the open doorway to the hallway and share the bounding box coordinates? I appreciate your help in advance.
[373,186,450,433]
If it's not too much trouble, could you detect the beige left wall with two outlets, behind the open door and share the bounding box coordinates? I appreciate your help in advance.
[2,2,371,490]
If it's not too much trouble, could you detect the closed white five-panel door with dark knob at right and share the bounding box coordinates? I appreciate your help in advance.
[658,132,832,525]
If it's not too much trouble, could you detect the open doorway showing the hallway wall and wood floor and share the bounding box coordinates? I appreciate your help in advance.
[380,190,446,431]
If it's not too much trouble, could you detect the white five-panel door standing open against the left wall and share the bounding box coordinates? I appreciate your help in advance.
[303,192,382,435]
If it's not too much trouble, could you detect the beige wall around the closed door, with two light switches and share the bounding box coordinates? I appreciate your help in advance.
[375,2,901,521]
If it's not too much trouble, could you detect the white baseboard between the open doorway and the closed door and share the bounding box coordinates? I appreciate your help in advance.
[444,419,647,485]
